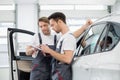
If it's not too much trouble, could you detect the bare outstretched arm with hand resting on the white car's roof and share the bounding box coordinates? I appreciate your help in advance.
[73,19,93,38]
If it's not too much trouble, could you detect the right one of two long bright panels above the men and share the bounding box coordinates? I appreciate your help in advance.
[75,5,107,10]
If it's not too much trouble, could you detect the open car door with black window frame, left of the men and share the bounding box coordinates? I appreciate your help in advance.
[7,28,34,80]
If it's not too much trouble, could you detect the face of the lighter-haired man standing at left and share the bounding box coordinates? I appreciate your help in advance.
[39,21,50,35]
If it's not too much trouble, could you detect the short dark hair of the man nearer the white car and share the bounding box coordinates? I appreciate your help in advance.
[48,12,66,24]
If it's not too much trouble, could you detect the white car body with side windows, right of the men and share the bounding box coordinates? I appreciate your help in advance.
[72,14,120,80]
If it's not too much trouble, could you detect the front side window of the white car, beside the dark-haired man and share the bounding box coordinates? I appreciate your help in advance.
[77,23,106,56]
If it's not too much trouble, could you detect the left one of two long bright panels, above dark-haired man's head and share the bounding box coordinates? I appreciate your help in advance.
[40,5,74,10]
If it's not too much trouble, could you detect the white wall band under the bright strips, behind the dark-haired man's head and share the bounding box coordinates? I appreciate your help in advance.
[39,10,108,19]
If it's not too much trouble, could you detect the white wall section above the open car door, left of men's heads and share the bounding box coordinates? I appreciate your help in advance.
[16,4,38,32]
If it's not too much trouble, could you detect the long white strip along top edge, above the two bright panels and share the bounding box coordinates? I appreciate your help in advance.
[39,0,116,5]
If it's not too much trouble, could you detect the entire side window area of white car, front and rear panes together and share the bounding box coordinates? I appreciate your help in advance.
[76,22,120,56]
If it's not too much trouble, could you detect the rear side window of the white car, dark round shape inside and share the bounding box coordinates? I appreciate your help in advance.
[96,22,120,52]
